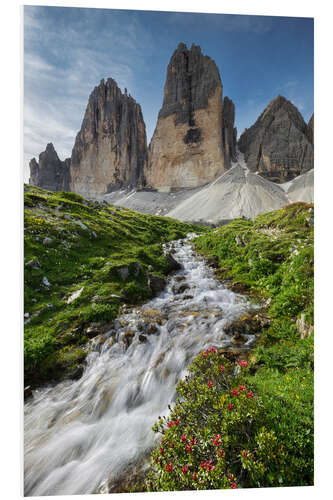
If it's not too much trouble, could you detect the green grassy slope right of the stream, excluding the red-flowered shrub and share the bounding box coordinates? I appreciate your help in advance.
[195,203,314,485]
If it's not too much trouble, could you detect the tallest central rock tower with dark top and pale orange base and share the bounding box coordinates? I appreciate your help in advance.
[145,43,231,191]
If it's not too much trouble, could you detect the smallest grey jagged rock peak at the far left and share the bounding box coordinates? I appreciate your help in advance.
[29,143,70,191]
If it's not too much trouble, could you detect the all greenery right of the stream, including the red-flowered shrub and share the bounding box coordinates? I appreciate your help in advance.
[146,203,314,491]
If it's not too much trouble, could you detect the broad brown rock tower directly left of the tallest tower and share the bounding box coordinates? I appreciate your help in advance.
[70,78,147,196]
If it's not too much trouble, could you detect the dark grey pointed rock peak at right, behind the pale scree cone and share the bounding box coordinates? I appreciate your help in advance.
[238,95,313,182]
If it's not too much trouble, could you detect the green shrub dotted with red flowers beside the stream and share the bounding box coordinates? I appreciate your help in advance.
[147,348,286,491]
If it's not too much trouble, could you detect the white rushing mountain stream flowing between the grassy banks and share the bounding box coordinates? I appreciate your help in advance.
[24,236,254,496]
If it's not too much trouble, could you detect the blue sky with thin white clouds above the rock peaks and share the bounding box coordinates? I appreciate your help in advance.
[24,6,314,181]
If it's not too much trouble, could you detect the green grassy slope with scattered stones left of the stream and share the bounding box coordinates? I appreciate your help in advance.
[24,186,200,384]
